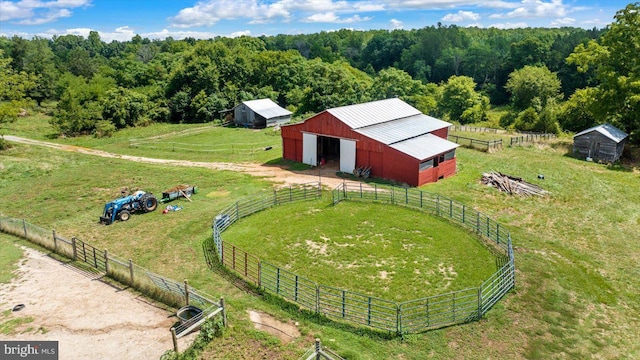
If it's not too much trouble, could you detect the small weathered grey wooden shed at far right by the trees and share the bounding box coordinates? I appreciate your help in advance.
[573,124,629,163]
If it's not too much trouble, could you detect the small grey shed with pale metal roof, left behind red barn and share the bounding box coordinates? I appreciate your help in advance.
[233,99,291,129]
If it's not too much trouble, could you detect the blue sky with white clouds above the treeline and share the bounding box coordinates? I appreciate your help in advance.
[0,0,629,42]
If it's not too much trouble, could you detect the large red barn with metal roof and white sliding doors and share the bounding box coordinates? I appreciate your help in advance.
[282,98,458,186]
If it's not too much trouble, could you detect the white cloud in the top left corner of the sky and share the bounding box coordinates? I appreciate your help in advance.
[0,0,91,25]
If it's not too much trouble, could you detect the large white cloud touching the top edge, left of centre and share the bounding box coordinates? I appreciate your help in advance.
[169,0,290,28]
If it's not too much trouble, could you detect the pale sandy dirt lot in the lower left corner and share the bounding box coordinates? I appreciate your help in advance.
[0,248,189,360]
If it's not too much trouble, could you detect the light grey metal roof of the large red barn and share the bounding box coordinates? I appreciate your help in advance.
[327,98,459,160]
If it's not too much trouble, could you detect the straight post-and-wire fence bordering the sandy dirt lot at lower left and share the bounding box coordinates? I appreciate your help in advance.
[0,216,226,337]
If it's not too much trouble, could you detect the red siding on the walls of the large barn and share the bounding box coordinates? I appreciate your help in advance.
[281,111,456,186]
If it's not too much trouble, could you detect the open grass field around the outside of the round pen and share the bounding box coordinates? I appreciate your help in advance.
[0,119,640,359]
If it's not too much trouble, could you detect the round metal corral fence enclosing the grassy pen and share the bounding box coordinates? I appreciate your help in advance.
[205,182,515,334]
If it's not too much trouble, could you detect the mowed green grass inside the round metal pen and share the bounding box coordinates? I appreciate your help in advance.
[223,201,496,302]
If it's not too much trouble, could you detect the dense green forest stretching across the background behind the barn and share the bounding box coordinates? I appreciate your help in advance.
[0,3,640,142]
